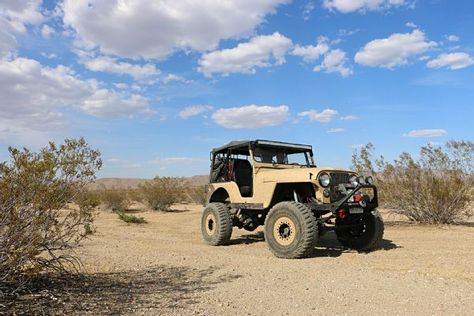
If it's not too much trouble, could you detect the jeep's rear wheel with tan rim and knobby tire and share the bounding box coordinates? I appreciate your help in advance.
[201,203,232,246]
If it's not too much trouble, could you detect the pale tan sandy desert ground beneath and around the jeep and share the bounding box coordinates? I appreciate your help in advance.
[5,205,474,315]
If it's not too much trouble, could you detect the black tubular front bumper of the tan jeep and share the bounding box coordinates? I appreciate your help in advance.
[309,184,379,214]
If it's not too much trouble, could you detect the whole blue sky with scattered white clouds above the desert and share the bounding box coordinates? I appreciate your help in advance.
[0,0,474,178]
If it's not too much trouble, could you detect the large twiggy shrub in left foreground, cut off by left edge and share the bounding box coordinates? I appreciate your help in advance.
[0,138,102,294]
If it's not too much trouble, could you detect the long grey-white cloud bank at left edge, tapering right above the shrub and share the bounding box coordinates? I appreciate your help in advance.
[0,58,153,133]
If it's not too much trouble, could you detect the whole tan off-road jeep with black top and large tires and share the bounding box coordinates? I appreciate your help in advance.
[201,140,384,258]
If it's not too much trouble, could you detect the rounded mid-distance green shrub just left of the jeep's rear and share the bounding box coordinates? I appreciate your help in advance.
[139,177,184,211]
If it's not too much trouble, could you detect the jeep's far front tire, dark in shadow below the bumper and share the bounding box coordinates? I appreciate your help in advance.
[336,210,384,251]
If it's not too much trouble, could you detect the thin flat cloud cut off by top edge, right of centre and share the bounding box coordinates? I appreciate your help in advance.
[323,0,414,13]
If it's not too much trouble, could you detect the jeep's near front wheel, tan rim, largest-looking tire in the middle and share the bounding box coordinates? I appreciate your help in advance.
[265,202,318,259]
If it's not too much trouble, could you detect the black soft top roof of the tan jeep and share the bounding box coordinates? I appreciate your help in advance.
[211,139,313,155]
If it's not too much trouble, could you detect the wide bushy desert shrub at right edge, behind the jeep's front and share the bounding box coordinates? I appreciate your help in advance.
[352,141,474,224]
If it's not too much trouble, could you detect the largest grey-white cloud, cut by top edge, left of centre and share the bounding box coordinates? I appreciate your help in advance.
[62,0,288,59]
